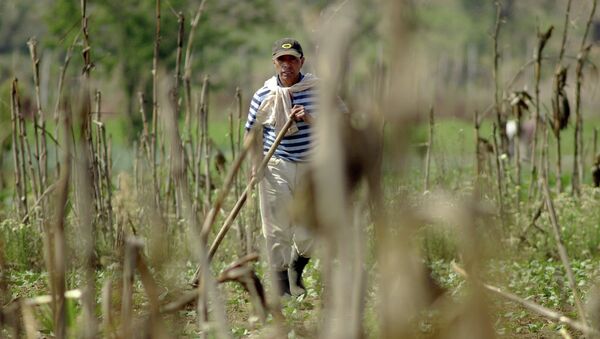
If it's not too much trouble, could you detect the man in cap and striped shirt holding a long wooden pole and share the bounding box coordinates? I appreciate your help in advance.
[246,38,317,295]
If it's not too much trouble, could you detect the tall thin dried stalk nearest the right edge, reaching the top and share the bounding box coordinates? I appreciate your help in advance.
[571,0,598,196]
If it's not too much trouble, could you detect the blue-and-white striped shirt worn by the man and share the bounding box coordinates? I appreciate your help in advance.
[246,74,317,162]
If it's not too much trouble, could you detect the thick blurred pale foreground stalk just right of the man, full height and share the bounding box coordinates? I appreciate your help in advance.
[313,2,368,338]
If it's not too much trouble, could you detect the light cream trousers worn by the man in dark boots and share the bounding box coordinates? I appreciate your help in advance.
[258,157,314,271]
